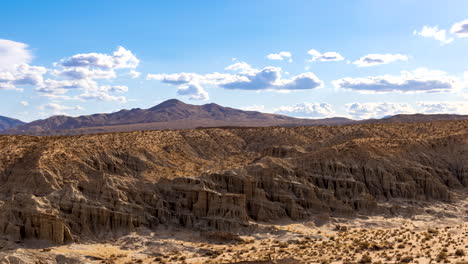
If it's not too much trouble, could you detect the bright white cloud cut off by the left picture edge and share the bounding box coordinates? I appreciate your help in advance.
[0,39,32,71]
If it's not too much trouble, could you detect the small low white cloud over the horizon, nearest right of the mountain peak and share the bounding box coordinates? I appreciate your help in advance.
[275,103,335,118]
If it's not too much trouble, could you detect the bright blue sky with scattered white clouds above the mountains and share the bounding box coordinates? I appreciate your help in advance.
[0,0,468,121]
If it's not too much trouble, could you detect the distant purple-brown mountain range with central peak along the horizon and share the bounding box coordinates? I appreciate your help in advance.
[0,99,468,135]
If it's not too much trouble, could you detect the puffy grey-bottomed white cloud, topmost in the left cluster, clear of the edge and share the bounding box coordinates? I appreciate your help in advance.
[59,46,140,70]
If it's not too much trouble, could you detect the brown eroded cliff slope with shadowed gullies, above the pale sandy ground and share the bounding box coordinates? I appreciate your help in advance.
[0,120,468,243]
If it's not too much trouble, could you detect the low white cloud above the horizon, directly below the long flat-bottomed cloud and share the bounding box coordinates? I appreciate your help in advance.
[346,103,416,119]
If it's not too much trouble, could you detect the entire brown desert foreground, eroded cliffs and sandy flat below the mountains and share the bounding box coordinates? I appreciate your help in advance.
[0,120,468,264]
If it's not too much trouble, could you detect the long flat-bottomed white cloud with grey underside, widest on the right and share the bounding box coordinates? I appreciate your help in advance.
[333,68,463,93]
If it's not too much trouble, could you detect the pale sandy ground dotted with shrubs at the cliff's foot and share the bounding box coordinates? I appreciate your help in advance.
[0,199,468,264]
